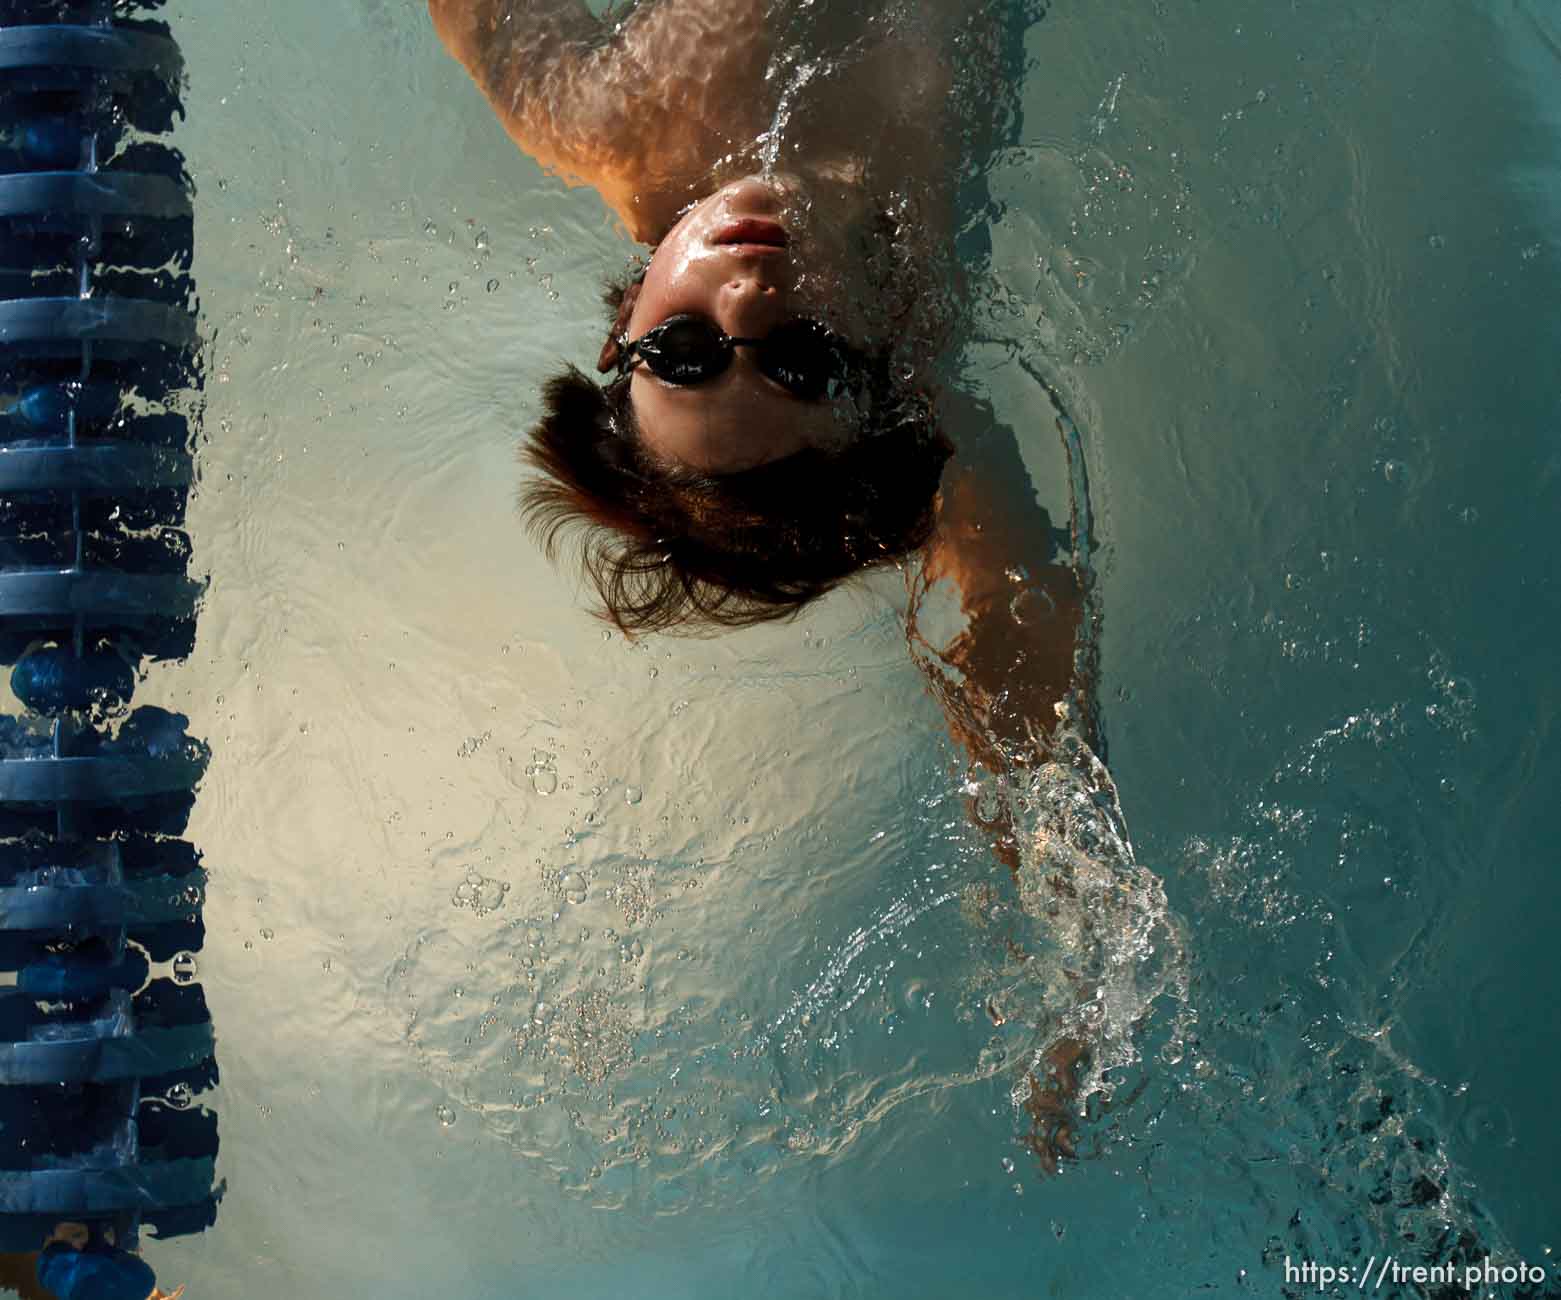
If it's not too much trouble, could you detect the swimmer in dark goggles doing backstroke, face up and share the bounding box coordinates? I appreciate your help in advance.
[429,0,1091,1167]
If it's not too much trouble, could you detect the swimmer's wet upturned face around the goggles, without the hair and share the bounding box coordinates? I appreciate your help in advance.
[626,178,860,474]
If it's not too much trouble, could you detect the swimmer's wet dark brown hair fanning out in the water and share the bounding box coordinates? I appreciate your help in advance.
[520,282,952,635]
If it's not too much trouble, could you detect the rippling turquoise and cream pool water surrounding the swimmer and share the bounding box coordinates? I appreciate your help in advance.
[128,0,1561,1297]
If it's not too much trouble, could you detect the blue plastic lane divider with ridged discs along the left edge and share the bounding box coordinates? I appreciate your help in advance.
[0,0,219,1300]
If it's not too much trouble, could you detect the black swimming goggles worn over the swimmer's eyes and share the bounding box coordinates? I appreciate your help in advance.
[618,315,860,401]
